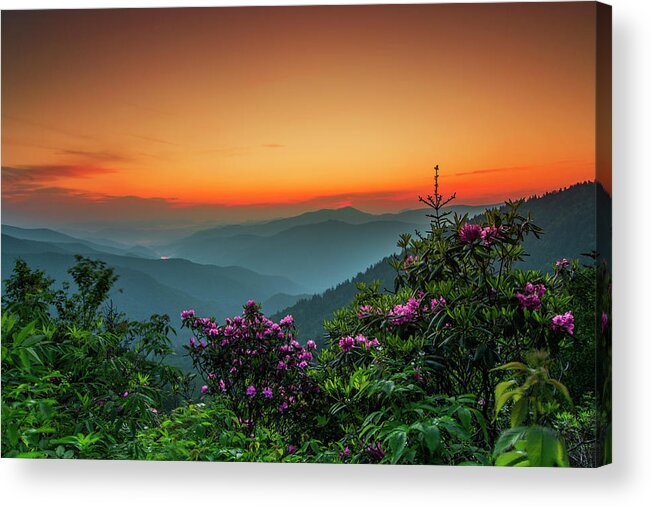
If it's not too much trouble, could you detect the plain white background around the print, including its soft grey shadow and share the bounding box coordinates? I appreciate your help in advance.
[0,0,651,507]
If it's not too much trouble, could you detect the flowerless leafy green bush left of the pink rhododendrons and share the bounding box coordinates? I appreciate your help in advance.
[2,259,191,458]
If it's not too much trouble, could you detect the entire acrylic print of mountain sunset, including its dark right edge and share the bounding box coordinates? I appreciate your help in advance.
[2,2,612,467]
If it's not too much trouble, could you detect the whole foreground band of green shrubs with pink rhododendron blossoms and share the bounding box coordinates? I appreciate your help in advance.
[2,168,612,467]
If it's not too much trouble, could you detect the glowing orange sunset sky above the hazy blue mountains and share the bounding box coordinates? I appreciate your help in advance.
[2,3,595,224]
